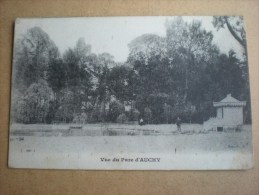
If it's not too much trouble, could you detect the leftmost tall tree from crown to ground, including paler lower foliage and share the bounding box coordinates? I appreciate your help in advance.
[12,27,60,123]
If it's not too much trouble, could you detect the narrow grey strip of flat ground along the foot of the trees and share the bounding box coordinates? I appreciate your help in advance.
[10,123,212,137]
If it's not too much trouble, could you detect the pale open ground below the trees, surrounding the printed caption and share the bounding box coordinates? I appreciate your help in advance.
[9,125,252,169]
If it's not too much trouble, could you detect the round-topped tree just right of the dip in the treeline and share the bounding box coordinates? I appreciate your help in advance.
[127,34,171,115]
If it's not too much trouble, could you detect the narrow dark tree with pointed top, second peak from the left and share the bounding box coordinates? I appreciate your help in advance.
[60,39,92,118]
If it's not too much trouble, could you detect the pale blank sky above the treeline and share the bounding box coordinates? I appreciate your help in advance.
[15,16,246,62]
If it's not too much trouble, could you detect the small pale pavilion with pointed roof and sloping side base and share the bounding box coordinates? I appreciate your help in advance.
[203,94,246,131]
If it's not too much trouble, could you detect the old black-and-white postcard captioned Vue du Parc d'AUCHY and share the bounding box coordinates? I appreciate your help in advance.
[9,16,253,170]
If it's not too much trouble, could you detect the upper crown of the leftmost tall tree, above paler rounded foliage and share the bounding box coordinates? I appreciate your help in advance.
[14,27,59,91]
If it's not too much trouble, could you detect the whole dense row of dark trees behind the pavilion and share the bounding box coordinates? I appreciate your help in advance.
[12,17,251,124]
